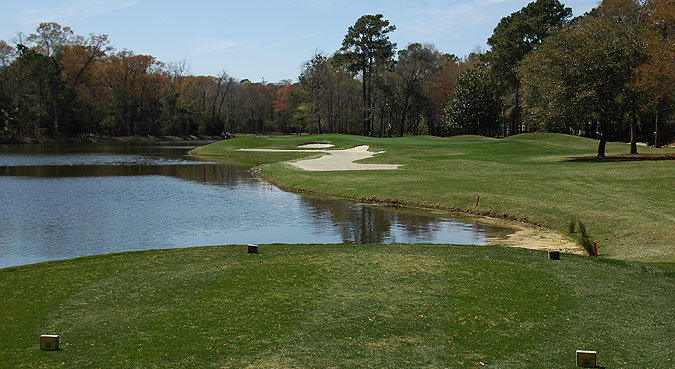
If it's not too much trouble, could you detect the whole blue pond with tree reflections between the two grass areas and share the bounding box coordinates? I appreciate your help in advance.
[0,142,505,268]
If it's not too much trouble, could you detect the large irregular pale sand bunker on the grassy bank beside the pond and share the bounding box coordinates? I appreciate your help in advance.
[239,145,400,172]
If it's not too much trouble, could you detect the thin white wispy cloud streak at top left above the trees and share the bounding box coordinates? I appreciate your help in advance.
[20,0,136,24]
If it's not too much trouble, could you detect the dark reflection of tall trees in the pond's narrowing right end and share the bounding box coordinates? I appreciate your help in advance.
[301,197,444,243]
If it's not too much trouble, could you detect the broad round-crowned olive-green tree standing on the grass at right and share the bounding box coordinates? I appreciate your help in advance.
[518,0,642,157]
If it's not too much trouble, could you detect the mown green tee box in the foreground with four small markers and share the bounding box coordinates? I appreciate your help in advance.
[0,245,675,368]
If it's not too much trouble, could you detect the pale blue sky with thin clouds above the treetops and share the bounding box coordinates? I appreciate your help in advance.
[0,0,598,82]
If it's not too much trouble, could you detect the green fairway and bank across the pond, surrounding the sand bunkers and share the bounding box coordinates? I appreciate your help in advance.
[194,133,675,268]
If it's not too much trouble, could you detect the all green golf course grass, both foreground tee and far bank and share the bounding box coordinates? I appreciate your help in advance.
[0,133,675,369]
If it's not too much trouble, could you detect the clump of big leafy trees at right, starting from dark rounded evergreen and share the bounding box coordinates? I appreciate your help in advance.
[456,0,675,156]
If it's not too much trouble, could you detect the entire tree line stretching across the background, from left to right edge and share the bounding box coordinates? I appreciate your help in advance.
[0,0,675,155]
